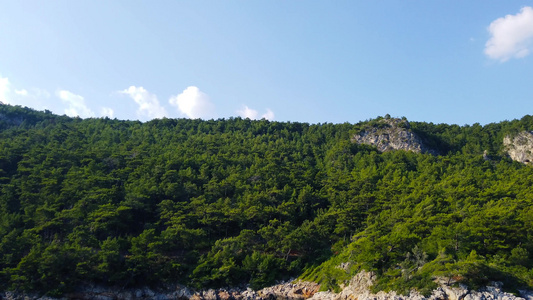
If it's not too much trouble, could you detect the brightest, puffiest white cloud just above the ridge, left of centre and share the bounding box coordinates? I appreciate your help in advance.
[168,86,215,119]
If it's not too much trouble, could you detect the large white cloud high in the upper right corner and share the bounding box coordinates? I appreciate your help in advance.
[485,6,533,62]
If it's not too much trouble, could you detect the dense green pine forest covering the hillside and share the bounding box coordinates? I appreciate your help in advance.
[0,105,533,296]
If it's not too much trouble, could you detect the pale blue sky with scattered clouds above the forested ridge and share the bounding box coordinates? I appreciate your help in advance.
[0,0,533,125]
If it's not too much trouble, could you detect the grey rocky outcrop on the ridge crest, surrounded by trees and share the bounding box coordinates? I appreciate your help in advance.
[352,118,436,154]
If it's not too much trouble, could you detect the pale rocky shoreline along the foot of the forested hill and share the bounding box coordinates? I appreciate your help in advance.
[0,272,533,300]
